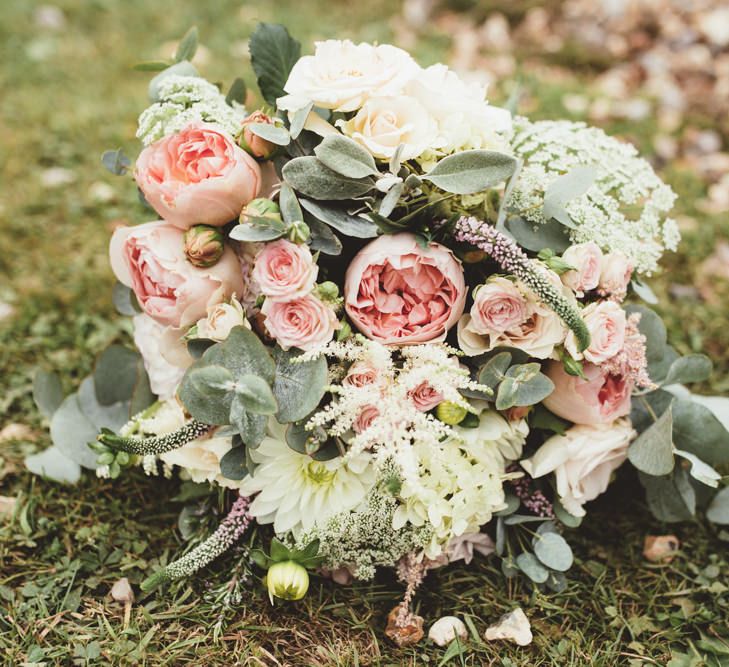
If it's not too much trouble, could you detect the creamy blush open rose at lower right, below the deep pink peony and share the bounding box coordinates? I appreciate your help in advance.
[521,419,635,516]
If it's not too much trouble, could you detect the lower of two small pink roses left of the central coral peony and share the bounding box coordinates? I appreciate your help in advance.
[261,294,339,352]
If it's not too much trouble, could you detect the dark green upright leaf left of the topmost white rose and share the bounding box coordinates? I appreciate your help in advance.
[249,23,301,106]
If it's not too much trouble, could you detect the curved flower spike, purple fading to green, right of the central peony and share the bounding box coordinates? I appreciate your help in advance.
[454,216,590,351]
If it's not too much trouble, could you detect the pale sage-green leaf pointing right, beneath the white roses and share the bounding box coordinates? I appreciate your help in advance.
[423,150,516,195]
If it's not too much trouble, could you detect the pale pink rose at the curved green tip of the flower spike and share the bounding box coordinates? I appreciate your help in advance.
[564,301,627,365]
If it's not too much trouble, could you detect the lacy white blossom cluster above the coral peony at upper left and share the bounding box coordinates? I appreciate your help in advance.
[137,75,246,146]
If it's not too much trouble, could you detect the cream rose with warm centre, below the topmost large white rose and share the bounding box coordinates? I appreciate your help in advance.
[337,96,436,160]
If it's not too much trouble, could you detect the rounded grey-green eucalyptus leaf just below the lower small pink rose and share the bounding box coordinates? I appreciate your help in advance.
[273,347,327,424]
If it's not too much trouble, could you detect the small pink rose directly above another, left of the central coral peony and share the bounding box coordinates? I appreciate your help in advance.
[253,239,319,301]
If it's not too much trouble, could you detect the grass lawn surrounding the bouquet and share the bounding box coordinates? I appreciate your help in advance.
[0,0,729,667]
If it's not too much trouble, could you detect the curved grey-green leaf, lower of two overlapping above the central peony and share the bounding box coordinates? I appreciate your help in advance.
[282,155,374,200]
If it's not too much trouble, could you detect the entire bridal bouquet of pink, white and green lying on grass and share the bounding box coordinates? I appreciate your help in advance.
[28,24,729,641]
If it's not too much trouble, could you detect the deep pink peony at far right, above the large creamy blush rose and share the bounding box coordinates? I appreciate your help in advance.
[544,361,634,425]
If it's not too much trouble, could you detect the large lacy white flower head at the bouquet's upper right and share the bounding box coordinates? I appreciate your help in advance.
[509,118,680,275]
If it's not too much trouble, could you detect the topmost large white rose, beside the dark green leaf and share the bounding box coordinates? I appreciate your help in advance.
[277,39,420,112]
